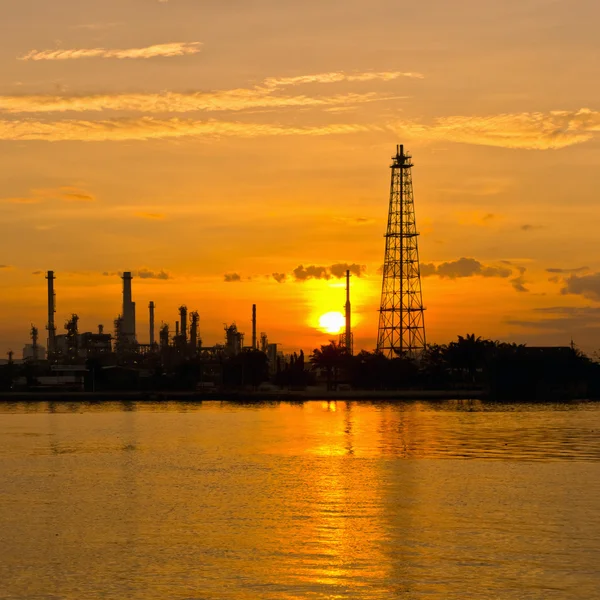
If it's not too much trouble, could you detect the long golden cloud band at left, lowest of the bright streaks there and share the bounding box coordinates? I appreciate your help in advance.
[0,117,381,142]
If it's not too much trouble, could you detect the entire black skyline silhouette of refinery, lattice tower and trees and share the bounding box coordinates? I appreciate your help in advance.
[0,145,600,399]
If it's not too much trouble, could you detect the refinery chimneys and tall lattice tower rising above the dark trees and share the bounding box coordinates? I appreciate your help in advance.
[19,145,426,364]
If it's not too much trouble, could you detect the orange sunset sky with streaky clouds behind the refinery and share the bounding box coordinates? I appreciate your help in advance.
[0,0,600,357]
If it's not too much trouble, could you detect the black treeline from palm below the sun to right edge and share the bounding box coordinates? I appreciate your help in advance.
[310,334,600,400]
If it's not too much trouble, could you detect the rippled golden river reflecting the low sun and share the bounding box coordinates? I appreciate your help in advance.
[0,401,600,600]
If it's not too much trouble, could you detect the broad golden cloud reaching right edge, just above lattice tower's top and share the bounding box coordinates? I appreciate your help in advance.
[395,108,600,150]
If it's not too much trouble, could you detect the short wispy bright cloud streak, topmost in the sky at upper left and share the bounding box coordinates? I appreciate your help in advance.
[20,42,202,60]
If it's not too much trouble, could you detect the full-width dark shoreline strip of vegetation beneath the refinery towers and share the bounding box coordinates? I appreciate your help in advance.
[0,334,600,402]
